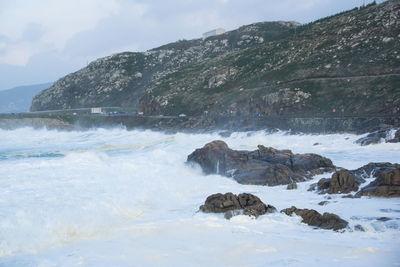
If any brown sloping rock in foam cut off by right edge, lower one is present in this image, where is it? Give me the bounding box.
[356,164,400,197]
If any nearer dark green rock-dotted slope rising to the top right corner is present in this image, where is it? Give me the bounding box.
[140,1,400,116]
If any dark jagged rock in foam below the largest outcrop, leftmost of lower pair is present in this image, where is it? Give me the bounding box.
[200,193,276,219]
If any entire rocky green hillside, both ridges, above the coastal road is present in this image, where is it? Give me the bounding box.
[31,0,400,115]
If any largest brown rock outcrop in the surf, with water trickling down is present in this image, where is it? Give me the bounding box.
[187,141,334,186]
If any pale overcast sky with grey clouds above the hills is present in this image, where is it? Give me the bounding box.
[0,0,383,90]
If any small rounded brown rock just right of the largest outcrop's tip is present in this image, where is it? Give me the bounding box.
[316,170,365,194]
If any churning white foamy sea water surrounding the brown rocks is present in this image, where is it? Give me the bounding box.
[0,128,400,267]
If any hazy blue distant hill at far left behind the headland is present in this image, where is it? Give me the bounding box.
[0,83,53,113]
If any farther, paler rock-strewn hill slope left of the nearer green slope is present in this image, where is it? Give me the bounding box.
[31,22,299,112]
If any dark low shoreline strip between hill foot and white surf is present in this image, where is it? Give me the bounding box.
[0,113,400,134]
